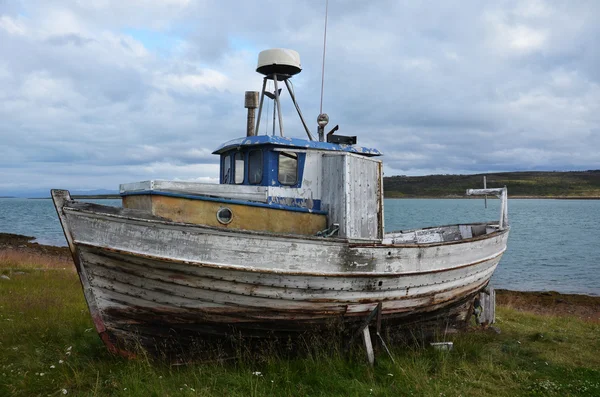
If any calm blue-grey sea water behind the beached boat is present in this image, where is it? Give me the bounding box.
[0,199,600,295]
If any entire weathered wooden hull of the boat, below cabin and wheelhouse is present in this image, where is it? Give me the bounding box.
[53,191,508,355]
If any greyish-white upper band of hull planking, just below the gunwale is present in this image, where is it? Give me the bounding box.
[65,207,508,277]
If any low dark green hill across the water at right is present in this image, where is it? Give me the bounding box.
[383,170,600,198]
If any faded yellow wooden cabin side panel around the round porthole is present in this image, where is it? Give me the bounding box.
[123,195,327,235]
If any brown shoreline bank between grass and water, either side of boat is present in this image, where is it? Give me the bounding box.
[0,233,600,321]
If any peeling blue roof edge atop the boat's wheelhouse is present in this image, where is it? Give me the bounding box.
[213,135,382,156]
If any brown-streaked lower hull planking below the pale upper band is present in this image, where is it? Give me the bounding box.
[81,243,497,331]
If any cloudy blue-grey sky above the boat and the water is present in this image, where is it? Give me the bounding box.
[0,0,600,195]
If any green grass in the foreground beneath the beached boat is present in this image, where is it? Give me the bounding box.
[0,268,600,396]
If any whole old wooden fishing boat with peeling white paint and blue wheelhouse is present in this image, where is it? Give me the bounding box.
[52,50,509,354]
